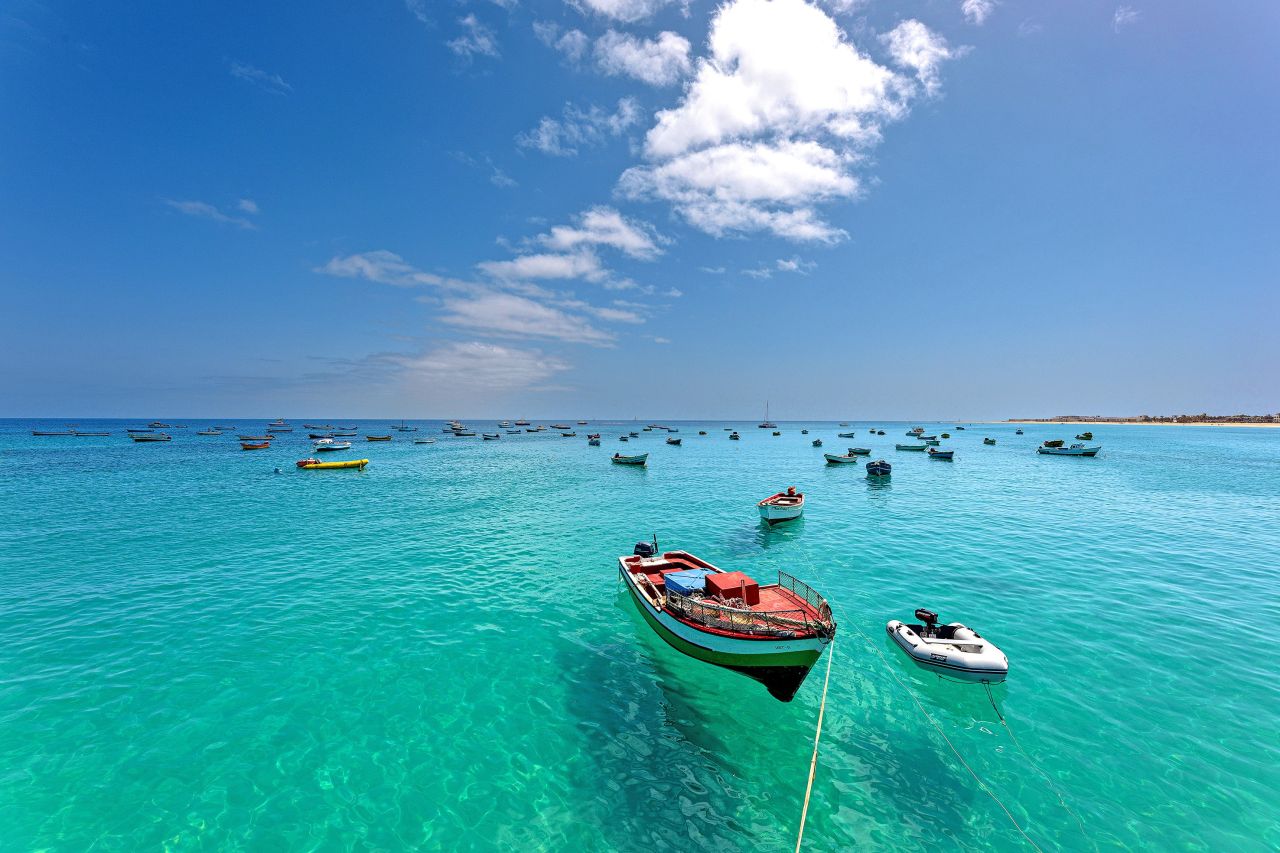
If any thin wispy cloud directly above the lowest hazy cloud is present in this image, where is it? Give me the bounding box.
[440,291,614,346]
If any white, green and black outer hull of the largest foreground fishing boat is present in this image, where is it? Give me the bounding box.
[618,562,829,702]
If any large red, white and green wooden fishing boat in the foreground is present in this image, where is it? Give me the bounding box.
[618,539,836,702]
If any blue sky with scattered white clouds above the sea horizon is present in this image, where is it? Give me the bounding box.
[0,0,1280,419]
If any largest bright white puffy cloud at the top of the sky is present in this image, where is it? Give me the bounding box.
[618,0,955,242]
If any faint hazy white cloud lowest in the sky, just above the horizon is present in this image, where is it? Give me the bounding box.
[394,341,570,392]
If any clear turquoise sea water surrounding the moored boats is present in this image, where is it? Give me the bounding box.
[0,420,1280,850]
